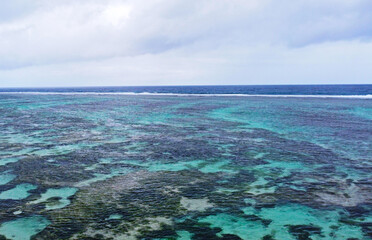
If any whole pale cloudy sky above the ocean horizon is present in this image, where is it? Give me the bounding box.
[0,0,372,87]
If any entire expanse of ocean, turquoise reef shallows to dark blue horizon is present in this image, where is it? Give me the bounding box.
[0,85,372,240]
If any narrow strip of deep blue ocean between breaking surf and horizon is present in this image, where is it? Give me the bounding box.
[0,84,372,95]
